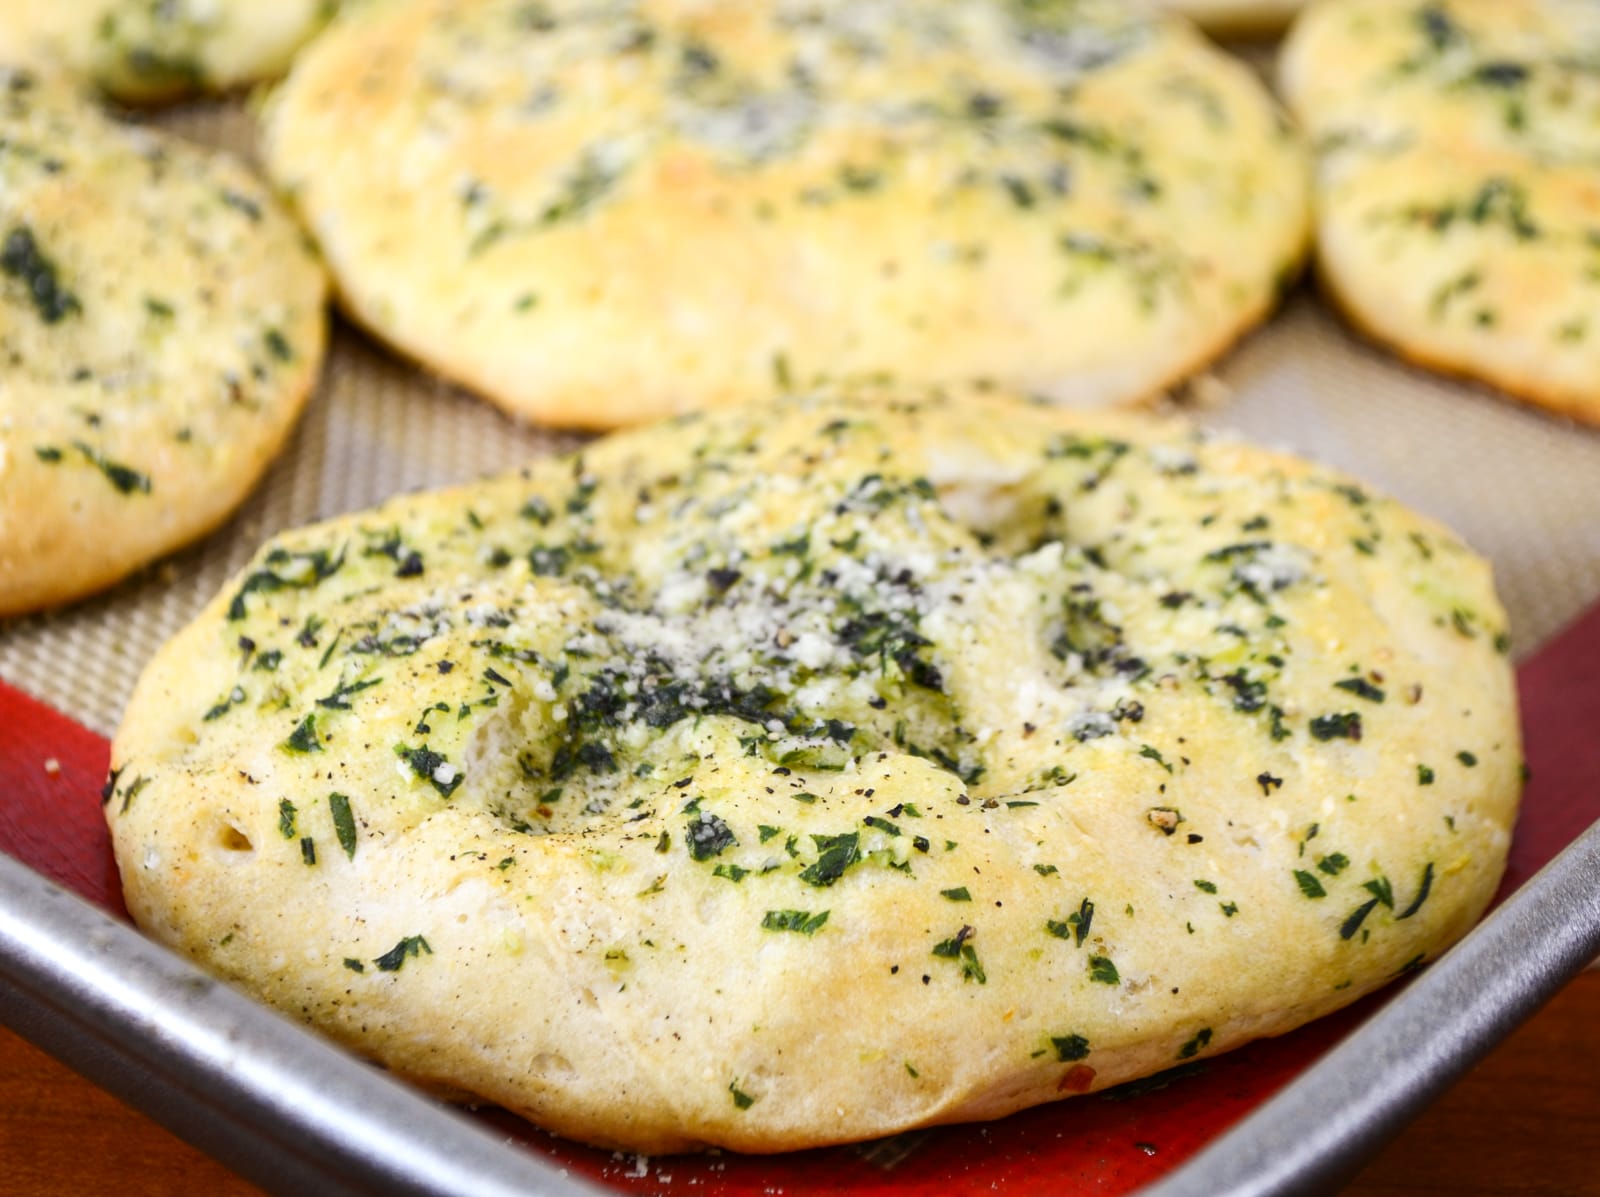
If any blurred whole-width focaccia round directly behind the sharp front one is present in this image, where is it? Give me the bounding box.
[266,0,1309,427]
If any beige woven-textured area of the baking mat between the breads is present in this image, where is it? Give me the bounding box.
[9,106,1600,733]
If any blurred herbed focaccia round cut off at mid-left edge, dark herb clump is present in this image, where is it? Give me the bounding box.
[0,69,326,615]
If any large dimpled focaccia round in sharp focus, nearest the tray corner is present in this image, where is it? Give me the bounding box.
[106,388,1520,1152]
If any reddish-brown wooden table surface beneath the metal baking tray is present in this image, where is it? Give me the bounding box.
[0,970,1600,1197]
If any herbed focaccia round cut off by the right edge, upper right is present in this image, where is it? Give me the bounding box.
[1282,0,1600,424]
